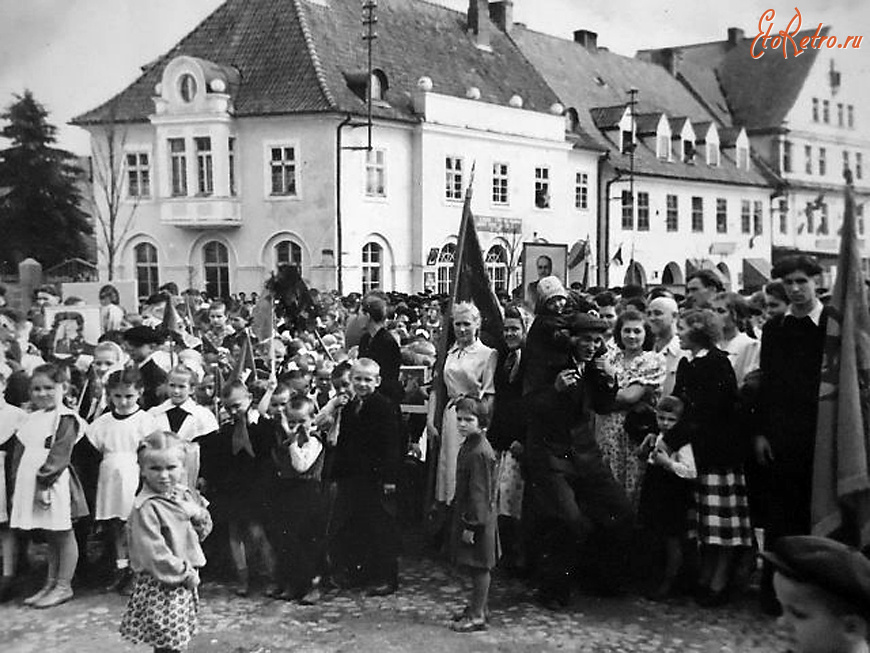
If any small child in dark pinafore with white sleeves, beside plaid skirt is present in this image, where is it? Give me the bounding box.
[638,396,698,600]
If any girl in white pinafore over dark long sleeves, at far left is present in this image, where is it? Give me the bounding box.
[10,365,84,608]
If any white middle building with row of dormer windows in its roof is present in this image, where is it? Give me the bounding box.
[511,26,773,289]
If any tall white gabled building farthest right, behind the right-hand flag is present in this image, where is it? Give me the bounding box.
[638,27,870,284]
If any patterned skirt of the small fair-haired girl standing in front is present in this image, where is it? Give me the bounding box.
[120,572,199,650]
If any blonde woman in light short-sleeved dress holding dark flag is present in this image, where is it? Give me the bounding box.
[427,302,498,505]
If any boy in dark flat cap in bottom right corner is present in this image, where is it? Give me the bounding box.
[762,535,870,653]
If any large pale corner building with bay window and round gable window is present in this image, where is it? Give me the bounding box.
[74,0,600,295]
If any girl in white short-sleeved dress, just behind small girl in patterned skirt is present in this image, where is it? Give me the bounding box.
[87,367,158,592]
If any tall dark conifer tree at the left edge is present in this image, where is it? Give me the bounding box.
[0,91,93,271]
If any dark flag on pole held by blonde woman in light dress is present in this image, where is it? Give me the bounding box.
[427,168,506,510]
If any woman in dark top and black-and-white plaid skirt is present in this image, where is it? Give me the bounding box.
[674,309,752,607]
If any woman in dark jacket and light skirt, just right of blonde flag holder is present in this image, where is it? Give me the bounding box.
[489,306,531,567]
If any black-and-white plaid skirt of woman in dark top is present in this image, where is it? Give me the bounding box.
[689,468,752,547]
